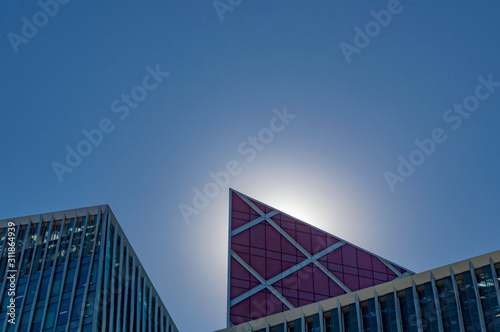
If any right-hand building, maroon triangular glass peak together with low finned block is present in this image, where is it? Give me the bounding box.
[220,191,500,332]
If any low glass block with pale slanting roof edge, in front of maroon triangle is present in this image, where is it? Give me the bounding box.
[219,251,500,332]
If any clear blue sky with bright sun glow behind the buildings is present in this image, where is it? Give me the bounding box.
[0,0,500,331]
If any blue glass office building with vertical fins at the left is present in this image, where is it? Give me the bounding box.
[0,205,178,332]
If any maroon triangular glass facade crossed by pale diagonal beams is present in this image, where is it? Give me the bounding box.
[228,190,413,326]
